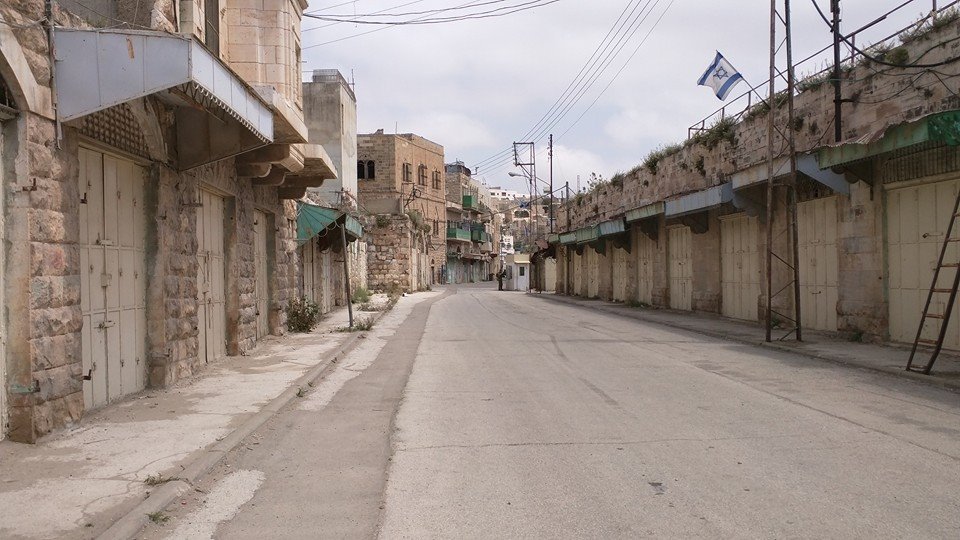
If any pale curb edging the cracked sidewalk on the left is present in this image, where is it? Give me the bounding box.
[97,306,393,540]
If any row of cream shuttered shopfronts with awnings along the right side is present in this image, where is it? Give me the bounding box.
[551,112,960,349]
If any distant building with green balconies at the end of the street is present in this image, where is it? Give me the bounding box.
[444,162,499,283]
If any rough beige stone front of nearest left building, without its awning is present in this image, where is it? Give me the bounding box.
[0,0,320,441]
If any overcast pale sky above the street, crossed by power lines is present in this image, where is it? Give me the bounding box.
[302,0,945,191]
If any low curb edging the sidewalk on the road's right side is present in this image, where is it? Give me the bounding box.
[539,294,960,392]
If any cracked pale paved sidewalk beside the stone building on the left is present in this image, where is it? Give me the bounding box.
[0,295,386,539]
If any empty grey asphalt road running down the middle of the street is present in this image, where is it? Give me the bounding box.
[146,286,960,538]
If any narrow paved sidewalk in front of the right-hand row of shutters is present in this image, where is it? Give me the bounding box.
[530,293,960,390]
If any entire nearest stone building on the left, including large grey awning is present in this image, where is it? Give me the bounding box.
[0,0,335,441]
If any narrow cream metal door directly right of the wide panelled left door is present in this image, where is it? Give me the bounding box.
[197,189,227,362]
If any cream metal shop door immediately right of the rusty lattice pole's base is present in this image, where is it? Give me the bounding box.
[797,196,840,332]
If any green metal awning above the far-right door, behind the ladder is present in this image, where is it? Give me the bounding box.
[817,110,960,169]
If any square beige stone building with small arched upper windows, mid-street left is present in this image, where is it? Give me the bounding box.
[357,129,447,290]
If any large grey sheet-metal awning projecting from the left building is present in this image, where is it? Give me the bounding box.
[54,28,274,170]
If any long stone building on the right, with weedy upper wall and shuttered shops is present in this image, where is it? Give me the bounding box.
[552,12,960,349]
